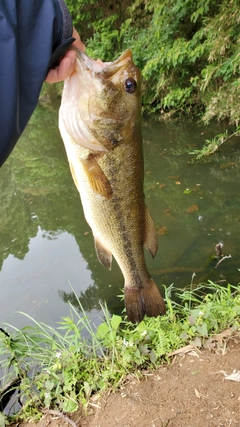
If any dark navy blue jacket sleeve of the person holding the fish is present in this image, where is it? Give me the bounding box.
[0,0,74,166]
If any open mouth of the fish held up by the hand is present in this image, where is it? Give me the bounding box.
[77,49,132,77]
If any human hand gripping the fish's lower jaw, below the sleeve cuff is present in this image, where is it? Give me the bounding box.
[46,28,85,83]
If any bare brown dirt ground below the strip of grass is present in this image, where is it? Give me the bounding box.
[10,333,240,427]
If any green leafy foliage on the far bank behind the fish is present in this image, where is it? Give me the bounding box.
[67,0,240,126]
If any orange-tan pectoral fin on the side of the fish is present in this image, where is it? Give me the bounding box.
[81,155,112,199]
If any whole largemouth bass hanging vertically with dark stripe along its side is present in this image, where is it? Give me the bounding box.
[59,49,166,323]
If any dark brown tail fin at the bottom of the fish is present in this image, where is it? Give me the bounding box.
[124,278,166,323]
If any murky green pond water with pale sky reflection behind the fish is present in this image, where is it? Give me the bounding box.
[0,92,240,327]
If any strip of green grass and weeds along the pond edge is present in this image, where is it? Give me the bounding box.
[0,282,240,425]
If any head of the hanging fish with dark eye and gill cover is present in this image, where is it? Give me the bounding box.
[61,49,141,151]
